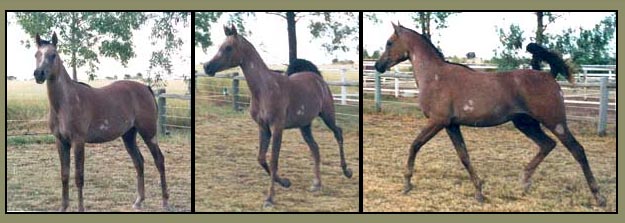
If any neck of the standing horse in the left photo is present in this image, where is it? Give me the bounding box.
[46,66,74,111]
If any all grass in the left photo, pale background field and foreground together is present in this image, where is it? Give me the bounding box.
[6,81,191,212]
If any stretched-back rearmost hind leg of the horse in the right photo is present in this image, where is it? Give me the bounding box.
[549,122,606,207]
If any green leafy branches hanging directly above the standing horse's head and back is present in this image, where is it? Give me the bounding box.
[15,12,146,80]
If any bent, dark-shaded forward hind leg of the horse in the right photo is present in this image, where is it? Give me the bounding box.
[512,116,556,193]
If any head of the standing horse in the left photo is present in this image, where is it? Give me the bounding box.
[34,32,62,84]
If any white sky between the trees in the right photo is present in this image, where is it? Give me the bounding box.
[363,12,616,59]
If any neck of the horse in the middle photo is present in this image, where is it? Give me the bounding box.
[241,47,279,100]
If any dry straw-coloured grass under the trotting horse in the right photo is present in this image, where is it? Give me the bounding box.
[363,114,616,212]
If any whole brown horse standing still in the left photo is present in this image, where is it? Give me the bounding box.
[34,33,169,211]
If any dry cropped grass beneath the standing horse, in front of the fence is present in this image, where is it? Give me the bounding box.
[6,139,191,212]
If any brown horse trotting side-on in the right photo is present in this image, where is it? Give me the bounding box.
[375,24,606,206]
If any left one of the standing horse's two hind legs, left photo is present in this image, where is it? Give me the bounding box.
[122,128,145,209]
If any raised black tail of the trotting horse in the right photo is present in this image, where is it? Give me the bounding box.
[525,43,575,83]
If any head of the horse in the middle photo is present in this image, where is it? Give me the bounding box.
[204,25,244,76]
